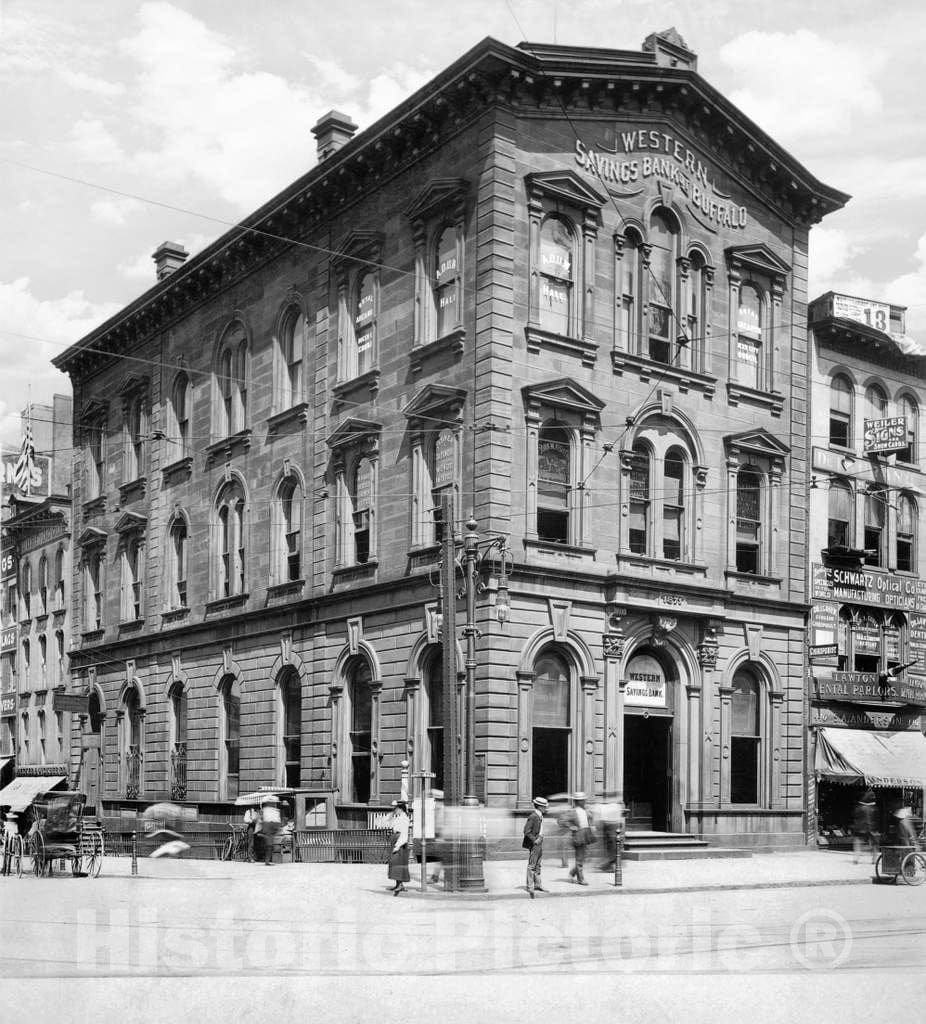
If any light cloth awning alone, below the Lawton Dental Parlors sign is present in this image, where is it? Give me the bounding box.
[813,728,926,787]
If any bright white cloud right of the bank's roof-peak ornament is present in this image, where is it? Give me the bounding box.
[719,29,885,143]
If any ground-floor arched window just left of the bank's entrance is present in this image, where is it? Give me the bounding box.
[532,649,573,796]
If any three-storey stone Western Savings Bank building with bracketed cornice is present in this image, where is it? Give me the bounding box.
[55,31,848,846]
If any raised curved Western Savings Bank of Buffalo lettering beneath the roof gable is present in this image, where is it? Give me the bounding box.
[576,128,747,228]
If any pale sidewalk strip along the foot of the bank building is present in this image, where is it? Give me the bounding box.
[100,850,875,901]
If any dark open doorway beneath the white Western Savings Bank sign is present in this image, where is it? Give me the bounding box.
[624,714,672,831]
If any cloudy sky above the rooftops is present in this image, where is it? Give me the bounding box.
[0,0,926,451]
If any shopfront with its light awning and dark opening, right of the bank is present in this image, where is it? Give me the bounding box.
[813,727,926,846]
